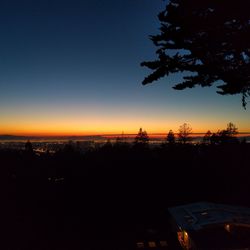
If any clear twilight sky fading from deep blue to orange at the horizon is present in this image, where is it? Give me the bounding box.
[0,0,250,135]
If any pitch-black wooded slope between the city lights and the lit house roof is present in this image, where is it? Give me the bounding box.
[0,140,250,249]
